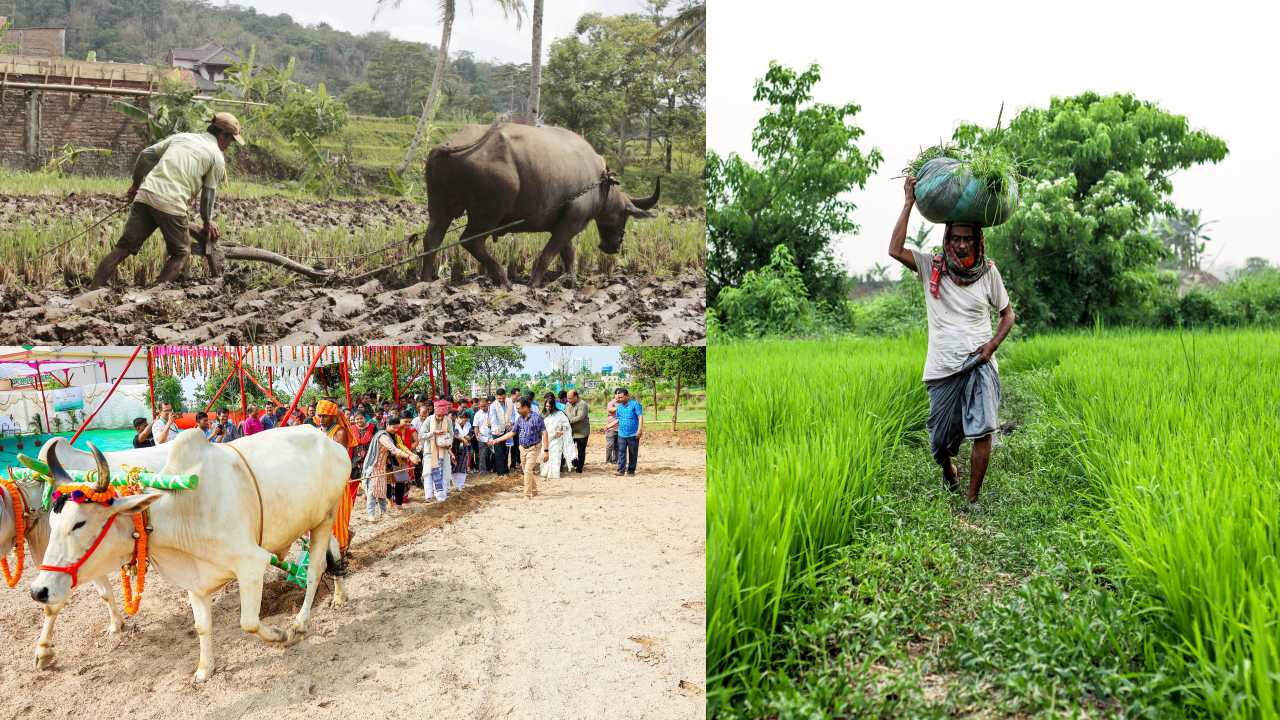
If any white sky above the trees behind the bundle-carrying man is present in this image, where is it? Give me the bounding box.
[707,0,1280,272]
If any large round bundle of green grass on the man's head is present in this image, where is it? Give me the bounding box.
[906,145,1018,227]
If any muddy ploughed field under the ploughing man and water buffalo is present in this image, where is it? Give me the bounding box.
[0,195,707,345]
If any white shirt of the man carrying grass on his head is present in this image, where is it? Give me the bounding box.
[911,250,1009,381]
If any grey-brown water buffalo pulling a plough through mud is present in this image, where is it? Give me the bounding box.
[420,123,662,288]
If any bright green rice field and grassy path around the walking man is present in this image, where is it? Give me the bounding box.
[707,331,1280,717]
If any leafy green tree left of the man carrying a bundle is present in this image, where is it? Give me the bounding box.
[707,63,883,305]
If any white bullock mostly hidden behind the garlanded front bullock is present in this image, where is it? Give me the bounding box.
[0,437,168,669]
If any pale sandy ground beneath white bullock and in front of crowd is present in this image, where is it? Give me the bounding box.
[0,432,705,720]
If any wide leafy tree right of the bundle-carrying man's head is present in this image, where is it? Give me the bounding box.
[955,92,1228,327]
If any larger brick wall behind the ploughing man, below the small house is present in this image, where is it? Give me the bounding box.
[0,90,151,174]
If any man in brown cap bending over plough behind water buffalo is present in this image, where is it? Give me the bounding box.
[90,113,244,290]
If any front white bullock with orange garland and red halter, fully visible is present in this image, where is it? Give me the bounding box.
[31,425,351,683]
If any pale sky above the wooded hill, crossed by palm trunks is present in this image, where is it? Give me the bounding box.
[236,0,650,63]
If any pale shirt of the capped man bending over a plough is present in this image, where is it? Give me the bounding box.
[134,132,227,218]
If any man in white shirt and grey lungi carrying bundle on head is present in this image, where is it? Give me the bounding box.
[888,177,1014,503]
